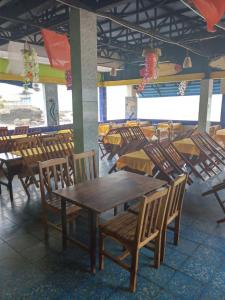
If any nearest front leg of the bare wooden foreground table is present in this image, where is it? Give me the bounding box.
[90,211,97,274]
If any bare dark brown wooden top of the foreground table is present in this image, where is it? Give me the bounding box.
[54,171,167,213]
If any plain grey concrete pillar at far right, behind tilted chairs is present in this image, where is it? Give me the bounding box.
[198,79,213,132]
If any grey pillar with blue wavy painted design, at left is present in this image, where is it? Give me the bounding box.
[44,83,59,126]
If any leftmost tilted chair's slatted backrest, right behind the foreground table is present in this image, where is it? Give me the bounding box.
[143,143,176,180]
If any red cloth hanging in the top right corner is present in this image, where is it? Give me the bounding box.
[192,0,225,32]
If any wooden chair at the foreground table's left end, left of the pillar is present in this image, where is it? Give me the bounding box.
[39,158,81,239]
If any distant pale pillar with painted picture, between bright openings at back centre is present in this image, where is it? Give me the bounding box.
[125,85,137,119]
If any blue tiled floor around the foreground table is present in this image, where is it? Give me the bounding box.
[0,162,225,300]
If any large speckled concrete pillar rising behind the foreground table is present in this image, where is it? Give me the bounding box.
[70,9,98,153]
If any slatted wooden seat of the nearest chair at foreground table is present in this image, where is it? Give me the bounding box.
[100,212,138,243]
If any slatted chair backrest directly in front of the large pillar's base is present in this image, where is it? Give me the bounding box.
[73,150,98,184]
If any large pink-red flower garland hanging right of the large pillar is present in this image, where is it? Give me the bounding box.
[137,48,161,93]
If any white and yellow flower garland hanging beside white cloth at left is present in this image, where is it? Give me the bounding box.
[22,42,39,91]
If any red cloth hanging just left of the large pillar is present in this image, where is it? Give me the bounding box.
[41,29,71,71]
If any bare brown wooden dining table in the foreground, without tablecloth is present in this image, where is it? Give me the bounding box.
[54,171,167,273]
